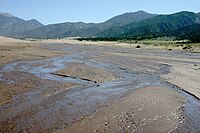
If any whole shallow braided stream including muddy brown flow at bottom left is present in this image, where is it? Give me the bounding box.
[0,44,200,132]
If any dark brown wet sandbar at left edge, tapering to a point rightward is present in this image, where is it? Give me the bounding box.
[0,71,78,106]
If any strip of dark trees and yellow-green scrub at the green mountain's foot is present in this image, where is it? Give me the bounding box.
[77,37,200,52]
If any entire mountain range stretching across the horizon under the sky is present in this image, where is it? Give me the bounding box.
[0,11,200,42]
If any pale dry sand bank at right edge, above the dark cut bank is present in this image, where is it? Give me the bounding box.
[161,63,200,99]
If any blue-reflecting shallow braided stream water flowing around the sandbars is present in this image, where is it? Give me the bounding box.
[0,44,200,132]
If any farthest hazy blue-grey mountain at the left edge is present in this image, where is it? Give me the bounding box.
[0,13,43,36]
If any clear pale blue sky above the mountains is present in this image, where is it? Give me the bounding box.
[0,0,200,24]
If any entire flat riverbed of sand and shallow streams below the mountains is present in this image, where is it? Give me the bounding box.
[0,38,200,132]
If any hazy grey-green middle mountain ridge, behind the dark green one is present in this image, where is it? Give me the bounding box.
[18,11,156,38]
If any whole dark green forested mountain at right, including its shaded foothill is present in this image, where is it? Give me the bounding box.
[80,12,200,43]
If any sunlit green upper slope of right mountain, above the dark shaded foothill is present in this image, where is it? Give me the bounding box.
[97,11,200,37]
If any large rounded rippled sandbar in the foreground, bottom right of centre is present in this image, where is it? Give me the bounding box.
[56,86,185,133]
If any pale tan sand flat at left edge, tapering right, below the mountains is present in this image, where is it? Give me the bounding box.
[0,36,67,66]
